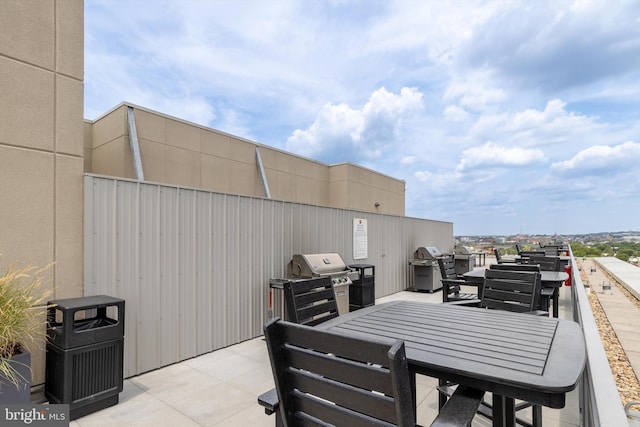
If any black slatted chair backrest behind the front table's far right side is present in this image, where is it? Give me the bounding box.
[480,268,541,313]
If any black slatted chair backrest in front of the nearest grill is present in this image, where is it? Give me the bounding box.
[284,277,339,326]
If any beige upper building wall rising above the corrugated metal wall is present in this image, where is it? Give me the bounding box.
[85,104,405,216]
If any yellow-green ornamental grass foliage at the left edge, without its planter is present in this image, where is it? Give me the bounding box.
[0,264,51,386]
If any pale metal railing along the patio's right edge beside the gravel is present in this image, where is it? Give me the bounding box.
[570,252,628,427]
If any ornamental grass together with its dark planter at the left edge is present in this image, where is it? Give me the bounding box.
[0,264,50,404]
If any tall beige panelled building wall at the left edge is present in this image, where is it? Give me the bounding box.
[0,0,84,384]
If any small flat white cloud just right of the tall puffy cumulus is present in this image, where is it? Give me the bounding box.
[456,142,544,172]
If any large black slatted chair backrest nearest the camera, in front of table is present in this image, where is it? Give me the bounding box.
[264,319,415,426]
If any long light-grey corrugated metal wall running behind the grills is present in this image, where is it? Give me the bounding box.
[85,175,453,376]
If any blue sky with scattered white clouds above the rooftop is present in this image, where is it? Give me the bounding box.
[84,0,640,236]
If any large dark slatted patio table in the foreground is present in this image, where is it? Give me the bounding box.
[316,301,585,426]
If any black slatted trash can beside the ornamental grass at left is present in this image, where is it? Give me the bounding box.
[45,295,124,420]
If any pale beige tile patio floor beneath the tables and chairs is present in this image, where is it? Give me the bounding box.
[71,287,579,427]
